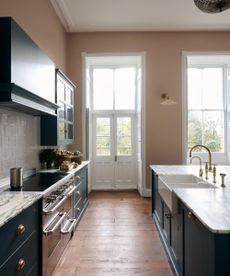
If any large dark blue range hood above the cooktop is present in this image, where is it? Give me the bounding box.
[0,17,57,115]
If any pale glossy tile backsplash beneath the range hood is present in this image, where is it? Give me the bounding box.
[0,107,40,179]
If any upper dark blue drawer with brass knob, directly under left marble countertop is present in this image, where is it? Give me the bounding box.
[0,202,39,266]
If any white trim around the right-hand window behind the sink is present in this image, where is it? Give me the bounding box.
[182,51,230,164]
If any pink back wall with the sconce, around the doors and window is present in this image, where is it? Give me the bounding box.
[67,32,230,186]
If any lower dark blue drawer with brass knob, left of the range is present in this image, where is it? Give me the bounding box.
[0,232,38,276]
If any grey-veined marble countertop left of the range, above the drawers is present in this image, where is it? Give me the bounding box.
[0,192,42,227]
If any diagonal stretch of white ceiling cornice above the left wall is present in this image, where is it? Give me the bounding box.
[50,0,73,32]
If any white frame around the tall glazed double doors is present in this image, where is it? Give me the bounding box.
[81,52,146,197]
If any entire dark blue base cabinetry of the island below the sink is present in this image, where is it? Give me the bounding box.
[152,172,230,276]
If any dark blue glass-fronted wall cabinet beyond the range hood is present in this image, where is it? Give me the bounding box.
[41,70,75,146]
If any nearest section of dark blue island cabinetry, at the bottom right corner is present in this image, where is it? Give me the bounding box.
[179,202,230,276]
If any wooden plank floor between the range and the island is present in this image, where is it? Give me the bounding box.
[53,192,173,276]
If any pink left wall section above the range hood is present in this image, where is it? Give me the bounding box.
[0,0,66,71]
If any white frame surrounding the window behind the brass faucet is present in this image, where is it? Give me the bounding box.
[182,52,230,164]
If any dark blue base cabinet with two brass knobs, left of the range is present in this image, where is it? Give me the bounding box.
[0,201,42,276]
